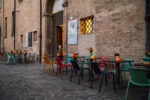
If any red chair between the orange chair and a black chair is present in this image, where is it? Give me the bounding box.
[55,58,72,79]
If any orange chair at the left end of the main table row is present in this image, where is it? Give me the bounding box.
[42,56,56,74]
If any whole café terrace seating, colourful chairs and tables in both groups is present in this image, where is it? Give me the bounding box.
[1,48,150,100]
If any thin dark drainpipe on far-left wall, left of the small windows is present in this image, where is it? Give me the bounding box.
[13,0,16,50]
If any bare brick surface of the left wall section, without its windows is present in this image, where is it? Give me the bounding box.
[1,0,40,54]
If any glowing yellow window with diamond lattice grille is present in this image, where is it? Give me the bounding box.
[80,16,94,34]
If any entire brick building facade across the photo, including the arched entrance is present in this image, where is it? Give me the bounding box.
[1,0,149,60]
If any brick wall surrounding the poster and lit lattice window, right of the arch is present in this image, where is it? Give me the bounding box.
[64,0,145,61]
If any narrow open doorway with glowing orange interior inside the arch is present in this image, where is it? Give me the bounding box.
[57,25,64,54]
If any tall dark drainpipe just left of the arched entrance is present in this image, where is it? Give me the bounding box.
[39,0,42,63]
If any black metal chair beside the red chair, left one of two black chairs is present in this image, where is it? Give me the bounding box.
[70,60,89,84]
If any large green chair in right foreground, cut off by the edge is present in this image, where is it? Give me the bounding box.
[125,67,150,100]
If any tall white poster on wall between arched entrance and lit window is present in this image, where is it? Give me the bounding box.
[68,20,77,44]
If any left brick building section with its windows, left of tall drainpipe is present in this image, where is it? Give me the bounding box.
[1,0,40,54]
